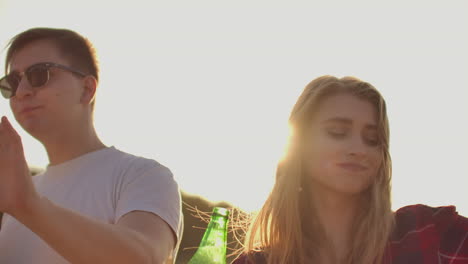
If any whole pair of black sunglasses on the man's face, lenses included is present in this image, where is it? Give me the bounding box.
[0,62,86,99]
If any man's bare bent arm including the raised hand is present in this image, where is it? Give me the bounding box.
[0,117,175,264]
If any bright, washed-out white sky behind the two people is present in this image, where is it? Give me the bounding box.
[0,0,468,215]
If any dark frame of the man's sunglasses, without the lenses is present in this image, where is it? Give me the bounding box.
[0,62,87,99]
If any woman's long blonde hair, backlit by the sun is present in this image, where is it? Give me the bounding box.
[244,76,394,264]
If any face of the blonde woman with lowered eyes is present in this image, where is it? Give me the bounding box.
[304,94,382,195]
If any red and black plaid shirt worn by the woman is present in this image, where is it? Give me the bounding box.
[233,204,468,264]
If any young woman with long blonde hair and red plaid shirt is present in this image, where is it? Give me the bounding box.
[233,76,468,264]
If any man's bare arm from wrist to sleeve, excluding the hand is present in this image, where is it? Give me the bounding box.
[13,198,175,264]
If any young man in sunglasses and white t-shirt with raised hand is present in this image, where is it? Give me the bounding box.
[0,28,182,264]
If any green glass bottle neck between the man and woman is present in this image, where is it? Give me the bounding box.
[188,207,229,264]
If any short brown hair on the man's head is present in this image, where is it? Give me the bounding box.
[5,28,99,81]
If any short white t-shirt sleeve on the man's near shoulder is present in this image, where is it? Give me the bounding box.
[115,162,182,242]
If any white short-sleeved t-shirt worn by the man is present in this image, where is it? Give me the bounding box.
[0,147,183,264]
